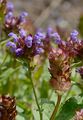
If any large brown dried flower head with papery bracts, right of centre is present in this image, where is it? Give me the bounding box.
[49,49,71,91]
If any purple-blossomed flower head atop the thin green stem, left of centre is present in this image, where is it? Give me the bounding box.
[6,29,44,58]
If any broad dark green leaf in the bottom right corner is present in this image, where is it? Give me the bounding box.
[56,97,83,120]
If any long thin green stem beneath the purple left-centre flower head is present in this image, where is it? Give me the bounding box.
[28,64,42,120]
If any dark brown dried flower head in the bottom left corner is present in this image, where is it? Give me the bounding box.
[0,96,17,120]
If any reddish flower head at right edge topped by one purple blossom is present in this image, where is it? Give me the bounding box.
[56,30,83,58]
